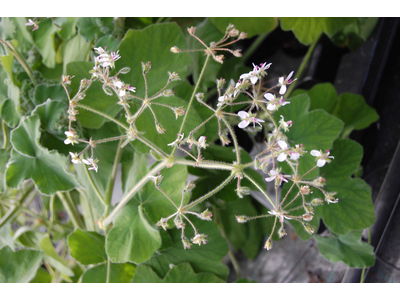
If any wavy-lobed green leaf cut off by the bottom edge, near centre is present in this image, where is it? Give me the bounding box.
[132,263,225,283]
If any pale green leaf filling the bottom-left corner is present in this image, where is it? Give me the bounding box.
[0,246,43,283]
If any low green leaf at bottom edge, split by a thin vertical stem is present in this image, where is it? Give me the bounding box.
[82,263,136,283]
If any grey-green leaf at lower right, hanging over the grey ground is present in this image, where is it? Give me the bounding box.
[315,231,375,268]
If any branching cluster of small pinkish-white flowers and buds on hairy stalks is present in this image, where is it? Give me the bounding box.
[63,25,338,250]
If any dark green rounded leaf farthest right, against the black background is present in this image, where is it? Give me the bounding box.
[335,93,379,137]
